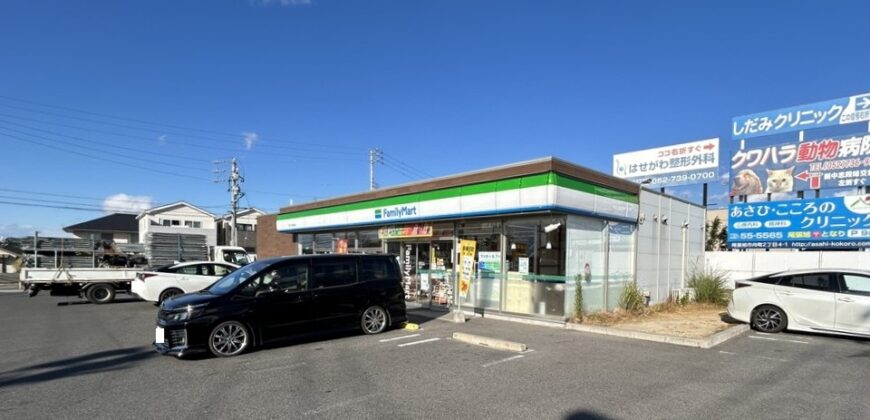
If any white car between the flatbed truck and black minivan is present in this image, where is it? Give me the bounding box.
[130,261,239,303]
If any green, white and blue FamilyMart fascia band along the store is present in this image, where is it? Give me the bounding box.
[277,172,638,232]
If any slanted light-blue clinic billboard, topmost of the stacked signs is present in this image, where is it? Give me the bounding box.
[731,93,870,140]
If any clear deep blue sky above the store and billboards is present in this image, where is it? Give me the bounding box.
[0,0,870,236]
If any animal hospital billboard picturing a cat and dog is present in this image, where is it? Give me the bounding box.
[731,134,870,196]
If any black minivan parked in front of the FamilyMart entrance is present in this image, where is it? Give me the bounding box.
[154,255,407,357]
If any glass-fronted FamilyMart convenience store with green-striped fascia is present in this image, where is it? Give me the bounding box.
[277,158,652,319]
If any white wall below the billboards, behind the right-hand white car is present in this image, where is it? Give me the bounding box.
[704,251,870,288]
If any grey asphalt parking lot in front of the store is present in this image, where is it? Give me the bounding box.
[0,291,870,419]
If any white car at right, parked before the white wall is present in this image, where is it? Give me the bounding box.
[728,269,870,337]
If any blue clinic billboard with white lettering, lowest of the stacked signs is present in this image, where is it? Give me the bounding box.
[728,195,870,248]
